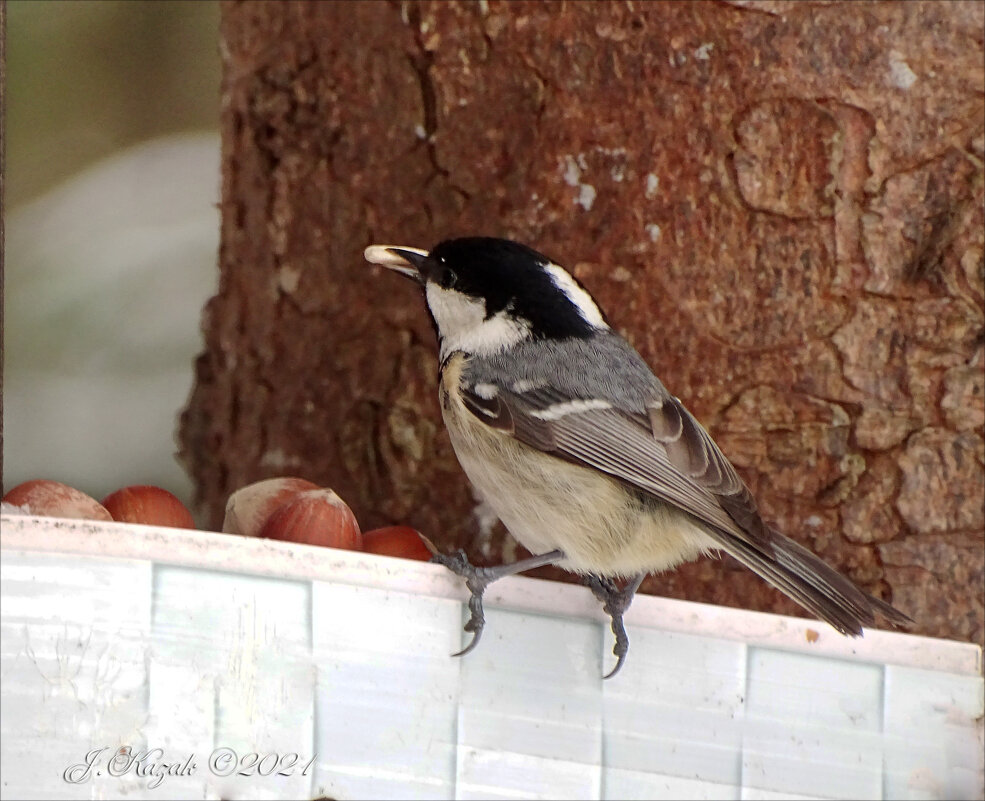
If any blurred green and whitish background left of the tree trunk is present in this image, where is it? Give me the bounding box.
[3,0,220,503]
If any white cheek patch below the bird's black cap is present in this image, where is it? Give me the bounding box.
[426,282,530,359]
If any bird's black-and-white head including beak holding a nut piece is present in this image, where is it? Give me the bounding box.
[365,237,608,350]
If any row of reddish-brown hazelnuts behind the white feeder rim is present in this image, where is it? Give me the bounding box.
[3,477,431,562]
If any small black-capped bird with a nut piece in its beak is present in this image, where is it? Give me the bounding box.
[365,237,912,678]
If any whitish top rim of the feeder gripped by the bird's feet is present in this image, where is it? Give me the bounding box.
[0,514,982,676]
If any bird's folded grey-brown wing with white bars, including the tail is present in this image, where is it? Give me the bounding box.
[460,345,909,635]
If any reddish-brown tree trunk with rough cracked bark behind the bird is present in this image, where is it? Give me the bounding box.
[180,0,985,643]
